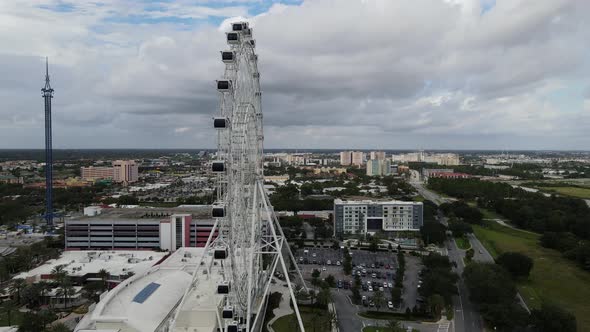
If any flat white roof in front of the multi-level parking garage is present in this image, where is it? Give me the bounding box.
[16,250,166,278]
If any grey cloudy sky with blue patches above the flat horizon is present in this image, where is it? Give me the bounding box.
[0,0,590,149]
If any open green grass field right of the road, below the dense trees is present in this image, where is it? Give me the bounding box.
[473,221,590,331]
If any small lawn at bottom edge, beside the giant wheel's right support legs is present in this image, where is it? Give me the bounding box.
[272,306,330,332]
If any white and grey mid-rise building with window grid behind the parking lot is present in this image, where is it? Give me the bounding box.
[334,199,423,236]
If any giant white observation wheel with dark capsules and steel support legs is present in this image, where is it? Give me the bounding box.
[169,22,305,332]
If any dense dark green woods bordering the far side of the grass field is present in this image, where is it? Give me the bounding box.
[429,179,590,270]
